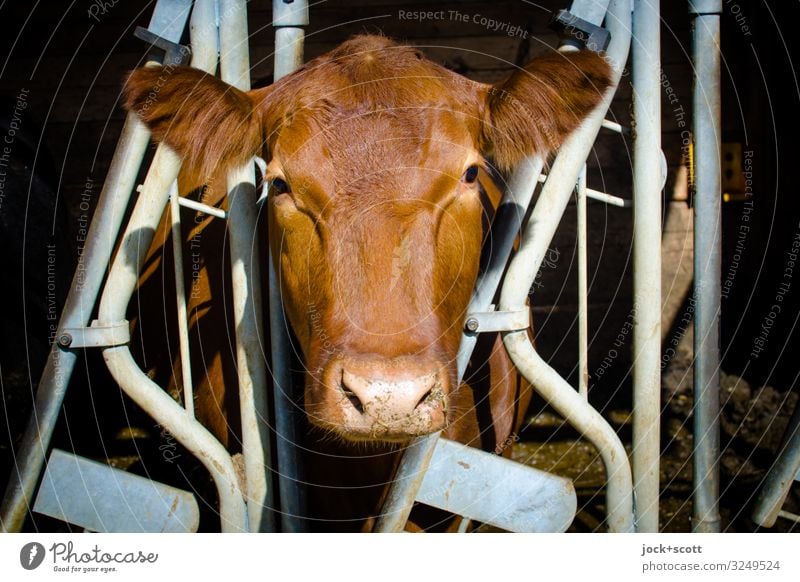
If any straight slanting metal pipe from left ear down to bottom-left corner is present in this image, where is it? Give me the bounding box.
[0,113,150,532]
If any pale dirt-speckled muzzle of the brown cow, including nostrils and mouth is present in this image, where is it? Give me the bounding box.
[320,357,449,441]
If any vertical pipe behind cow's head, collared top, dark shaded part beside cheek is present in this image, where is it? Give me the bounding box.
[269,0,308,532]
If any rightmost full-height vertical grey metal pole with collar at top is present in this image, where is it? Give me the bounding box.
[689,0,722,532]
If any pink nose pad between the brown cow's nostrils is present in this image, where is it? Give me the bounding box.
[342,370,437,420]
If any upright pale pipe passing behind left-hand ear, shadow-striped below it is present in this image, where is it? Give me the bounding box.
[219,0,275,532]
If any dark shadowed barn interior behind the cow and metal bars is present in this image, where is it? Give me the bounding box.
[0,0,800,531]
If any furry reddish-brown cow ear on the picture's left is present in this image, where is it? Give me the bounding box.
[123,67,262,180]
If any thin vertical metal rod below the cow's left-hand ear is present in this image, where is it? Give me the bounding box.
[169,180,194,416]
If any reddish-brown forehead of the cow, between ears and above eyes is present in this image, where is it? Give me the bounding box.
[268,37,482,188]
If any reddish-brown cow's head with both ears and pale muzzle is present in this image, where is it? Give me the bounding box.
[126,36,610,441]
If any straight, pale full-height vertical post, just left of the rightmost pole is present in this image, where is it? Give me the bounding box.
[632,0,663,532]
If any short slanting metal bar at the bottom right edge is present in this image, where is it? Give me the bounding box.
[753,404,800,527]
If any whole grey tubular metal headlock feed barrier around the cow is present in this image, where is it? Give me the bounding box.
[0,0,736,532]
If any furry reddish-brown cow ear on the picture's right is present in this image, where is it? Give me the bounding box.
[481,51,611,171]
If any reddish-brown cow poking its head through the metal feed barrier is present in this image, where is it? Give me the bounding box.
[124,35,611,530]
